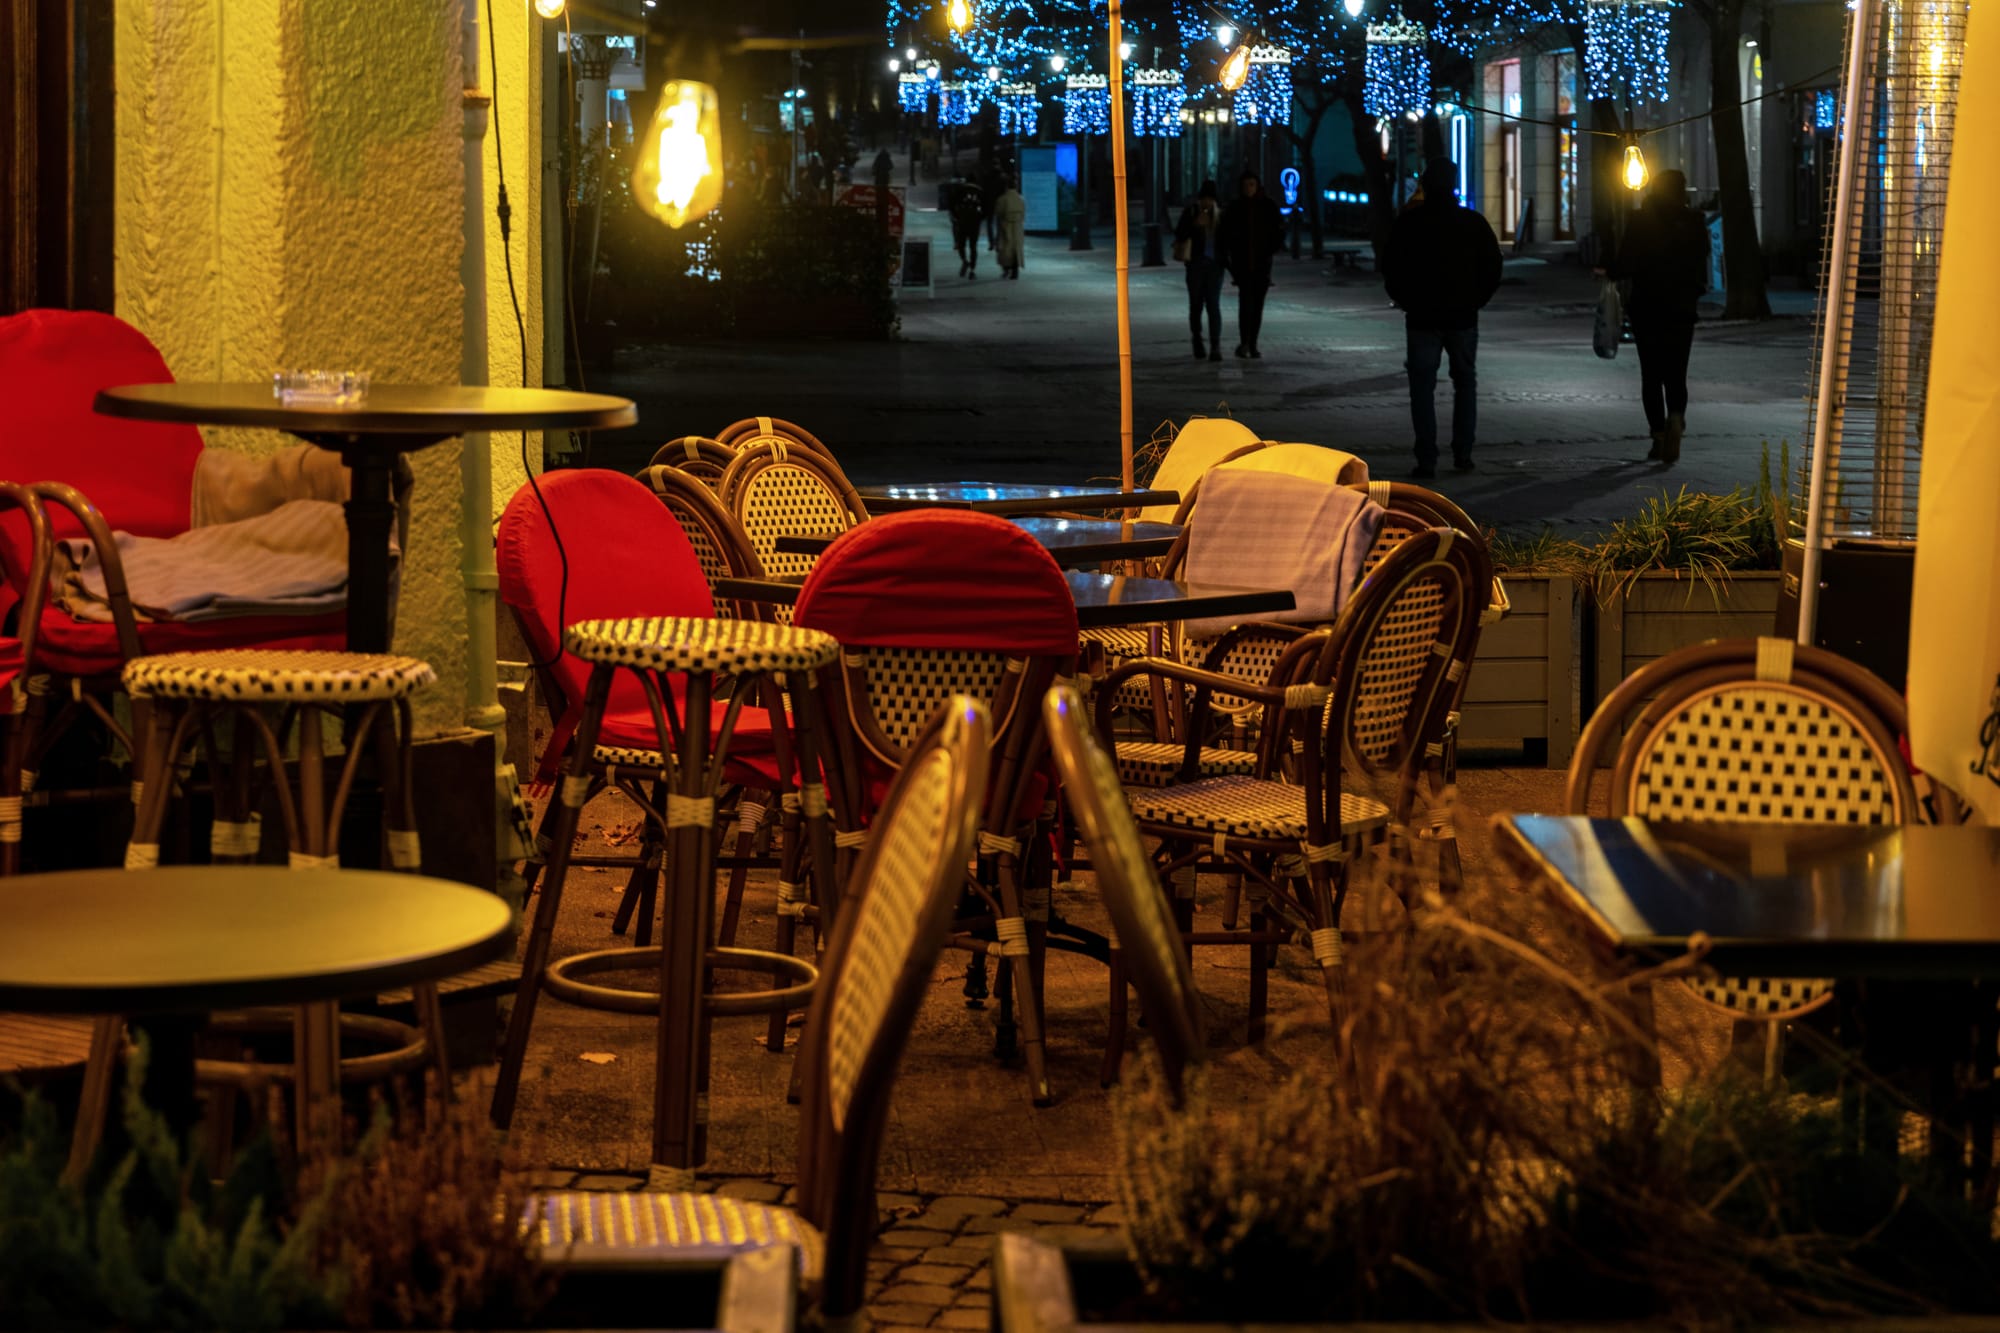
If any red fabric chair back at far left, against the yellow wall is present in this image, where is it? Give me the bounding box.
[0,310,202,586]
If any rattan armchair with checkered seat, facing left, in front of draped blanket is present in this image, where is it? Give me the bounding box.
[1098,528,1490,1016]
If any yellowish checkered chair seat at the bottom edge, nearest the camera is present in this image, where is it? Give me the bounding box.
[524,1189,826,1283]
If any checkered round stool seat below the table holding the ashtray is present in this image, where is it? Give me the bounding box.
[124,648,438,705]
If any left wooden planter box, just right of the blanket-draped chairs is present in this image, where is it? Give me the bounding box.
[1458,572,1584,769]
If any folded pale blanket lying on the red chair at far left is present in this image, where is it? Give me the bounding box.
[58,500,396,620]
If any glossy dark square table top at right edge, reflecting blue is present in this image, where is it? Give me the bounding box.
[1494,815,2000,981]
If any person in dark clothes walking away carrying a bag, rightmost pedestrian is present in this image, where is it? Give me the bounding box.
[1610,170,1708,466]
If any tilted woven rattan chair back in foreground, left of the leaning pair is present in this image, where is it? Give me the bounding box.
[798,699,990,1319]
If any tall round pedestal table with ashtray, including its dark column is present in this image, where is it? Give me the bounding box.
[94,380,638,652]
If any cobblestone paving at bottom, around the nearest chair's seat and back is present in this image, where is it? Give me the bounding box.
[516,1171,1124,1333]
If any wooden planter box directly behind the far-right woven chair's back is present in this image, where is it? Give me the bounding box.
[1590,570,1784,711]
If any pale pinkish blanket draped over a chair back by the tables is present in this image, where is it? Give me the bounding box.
[1182,466,1384,636]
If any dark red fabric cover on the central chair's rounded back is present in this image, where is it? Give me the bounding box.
[792,508,1076,656]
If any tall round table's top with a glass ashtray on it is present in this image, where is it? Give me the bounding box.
[94,380,638,440]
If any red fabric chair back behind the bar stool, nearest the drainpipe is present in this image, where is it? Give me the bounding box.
[496,468,716,711]
